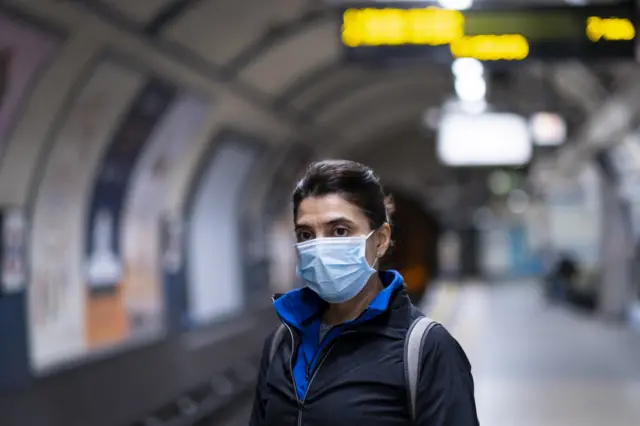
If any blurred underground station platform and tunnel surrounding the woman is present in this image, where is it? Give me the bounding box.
[0,0,640,426]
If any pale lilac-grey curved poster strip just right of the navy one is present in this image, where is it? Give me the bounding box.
[122,93,209,334]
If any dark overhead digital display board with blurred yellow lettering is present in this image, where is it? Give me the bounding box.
[340,2,637,62]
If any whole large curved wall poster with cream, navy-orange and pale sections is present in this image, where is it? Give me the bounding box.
[28,59,210,373]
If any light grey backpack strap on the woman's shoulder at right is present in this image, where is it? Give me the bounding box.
[404,316,438,421]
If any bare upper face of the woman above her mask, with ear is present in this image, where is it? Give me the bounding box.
[295,194,391,265]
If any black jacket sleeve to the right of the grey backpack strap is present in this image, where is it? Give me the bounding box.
[416,326,480,426]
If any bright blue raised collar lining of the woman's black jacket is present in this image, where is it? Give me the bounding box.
[273,270,404,329]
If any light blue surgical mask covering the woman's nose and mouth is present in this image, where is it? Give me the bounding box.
[296,231,376,303]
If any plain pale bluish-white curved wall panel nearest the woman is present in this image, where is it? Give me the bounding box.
[185,141,259,326]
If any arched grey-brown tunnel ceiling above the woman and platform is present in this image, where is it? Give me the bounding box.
[13,0,637,220]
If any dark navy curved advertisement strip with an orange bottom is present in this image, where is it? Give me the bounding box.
[84,79,177,348]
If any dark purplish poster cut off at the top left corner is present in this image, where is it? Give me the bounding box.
[0,12,60,157]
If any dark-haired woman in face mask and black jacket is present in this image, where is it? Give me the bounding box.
[251,161,479,426]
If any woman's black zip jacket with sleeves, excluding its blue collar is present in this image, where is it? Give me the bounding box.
[250,288,479,426]
